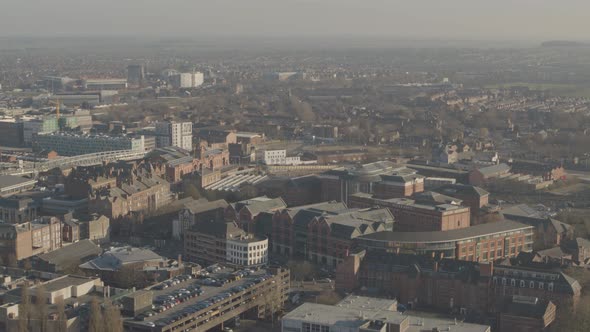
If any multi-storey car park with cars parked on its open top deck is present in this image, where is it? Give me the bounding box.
[124,268,290,332]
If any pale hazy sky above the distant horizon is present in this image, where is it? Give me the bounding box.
[0,0,590,40]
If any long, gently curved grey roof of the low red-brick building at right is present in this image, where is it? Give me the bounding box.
[359,220,533,243]
